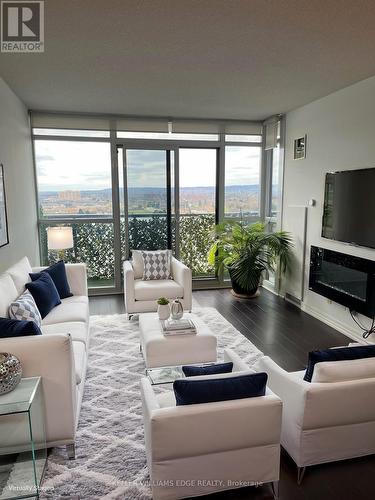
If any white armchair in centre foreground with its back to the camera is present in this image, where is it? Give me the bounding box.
[141,349,282,500]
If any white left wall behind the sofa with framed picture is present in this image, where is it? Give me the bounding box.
[0,78,39,273]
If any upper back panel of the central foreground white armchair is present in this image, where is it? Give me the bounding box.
[150,395,282,461]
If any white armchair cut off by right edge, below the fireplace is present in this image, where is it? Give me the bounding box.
[256,356,375,483]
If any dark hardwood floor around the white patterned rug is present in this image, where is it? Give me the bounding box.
[90,289,375,500]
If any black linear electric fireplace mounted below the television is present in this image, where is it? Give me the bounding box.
[309,246,375,318]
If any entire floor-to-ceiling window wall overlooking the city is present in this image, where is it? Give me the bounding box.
[33,115,279,293]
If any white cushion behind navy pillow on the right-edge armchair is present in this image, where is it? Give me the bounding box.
[311,358,375,383]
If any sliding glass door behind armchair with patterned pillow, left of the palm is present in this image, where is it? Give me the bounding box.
[119,145,218,278]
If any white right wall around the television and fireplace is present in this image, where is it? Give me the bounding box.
[283,77,375,342]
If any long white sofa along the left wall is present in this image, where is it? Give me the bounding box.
[0,257,89,458]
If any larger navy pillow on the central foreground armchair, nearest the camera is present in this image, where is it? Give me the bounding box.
[173,373,267,406]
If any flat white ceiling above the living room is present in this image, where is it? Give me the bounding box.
[0,0,375,120]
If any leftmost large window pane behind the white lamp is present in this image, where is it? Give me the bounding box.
[34,140,115,288]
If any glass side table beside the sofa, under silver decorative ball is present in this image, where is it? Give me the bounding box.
[0,377,47,500]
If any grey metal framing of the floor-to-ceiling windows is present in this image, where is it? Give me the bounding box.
[31,124,283,295]
